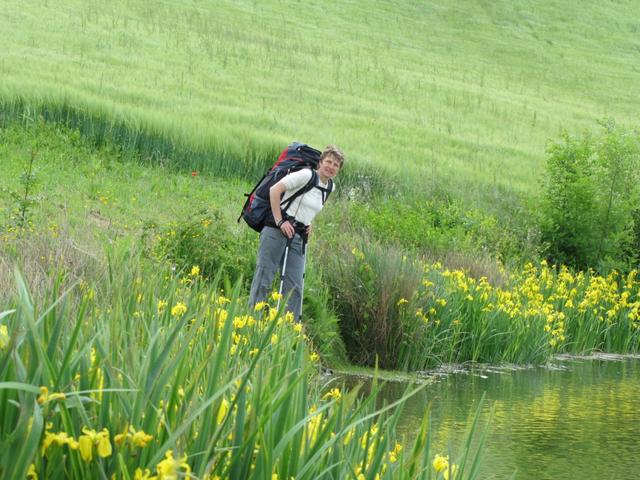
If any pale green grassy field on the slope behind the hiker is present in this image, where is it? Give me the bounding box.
[0,0,640,200]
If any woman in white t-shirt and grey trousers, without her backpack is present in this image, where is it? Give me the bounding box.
[249,145,344,322]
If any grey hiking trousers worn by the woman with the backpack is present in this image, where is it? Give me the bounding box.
[249,227,304,321]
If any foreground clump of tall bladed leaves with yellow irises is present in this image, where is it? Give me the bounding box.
[0,253,488,479]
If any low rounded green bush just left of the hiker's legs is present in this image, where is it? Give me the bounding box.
[145,210,258,281]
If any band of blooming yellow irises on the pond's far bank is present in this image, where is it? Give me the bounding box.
[416,262,640,348]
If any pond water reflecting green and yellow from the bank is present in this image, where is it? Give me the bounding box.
[336,356,640,480]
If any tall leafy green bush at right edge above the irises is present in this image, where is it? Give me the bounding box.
[541,122,640,270]
